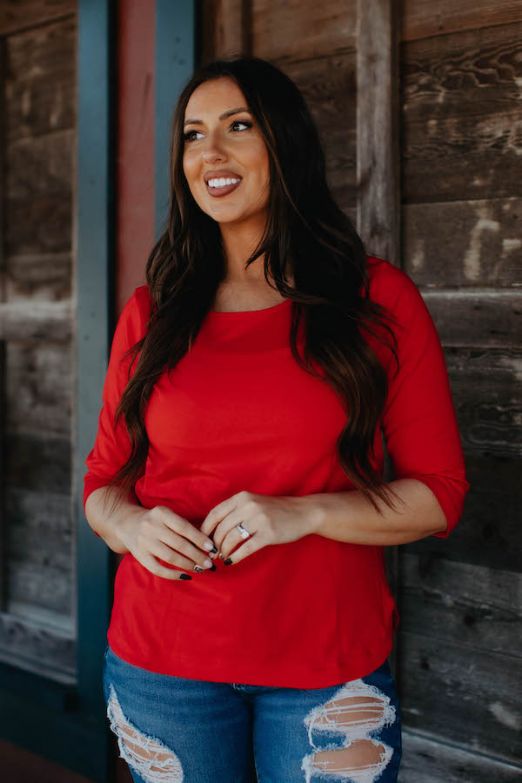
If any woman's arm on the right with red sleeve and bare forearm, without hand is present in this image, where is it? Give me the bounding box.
[303,264,470,545]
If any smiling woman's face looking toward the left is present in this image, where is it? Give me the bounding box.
[183,77,269,225]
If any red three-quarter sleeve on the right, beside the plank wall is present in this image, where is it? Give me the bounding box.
[374,267,470,538]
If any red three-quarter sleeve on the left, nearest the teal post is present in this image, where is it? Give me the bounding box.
[83,286,148,508]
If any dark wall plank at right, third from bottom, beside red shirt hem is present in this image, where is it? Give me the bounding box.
[400,547,522,658]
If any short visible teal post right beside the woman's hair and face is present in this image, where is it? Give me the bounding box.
[154,0,196,237]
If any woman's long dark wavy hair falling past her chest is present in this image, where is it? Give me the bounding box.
[103,57,397,511]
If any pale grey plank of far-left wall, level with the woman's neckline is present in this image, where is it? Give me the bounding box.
[0,302,73,343]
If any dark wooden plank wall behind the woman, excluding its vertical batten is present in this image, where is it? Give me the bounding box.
[201,0,522,783]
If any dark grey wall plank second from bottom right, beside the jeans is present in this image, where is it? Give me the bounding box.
[398,631,522,764]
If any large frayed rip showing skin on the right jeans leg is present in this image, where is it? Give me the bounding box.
[301,679,396,783]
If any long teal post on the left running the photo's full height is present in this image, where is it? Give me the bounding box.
[74,0,117,781]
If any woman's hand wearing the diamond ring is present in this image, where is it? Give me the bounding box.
[200,490,314,565]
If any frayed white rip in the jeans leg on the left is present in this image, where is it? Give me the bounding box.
[107,685,184,783]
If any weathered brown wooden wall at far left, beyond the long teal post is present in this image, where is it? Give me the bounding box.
[0,0,76,682]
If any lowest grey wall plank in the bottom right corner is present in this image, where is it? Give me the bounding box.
[399,729,522,783]
